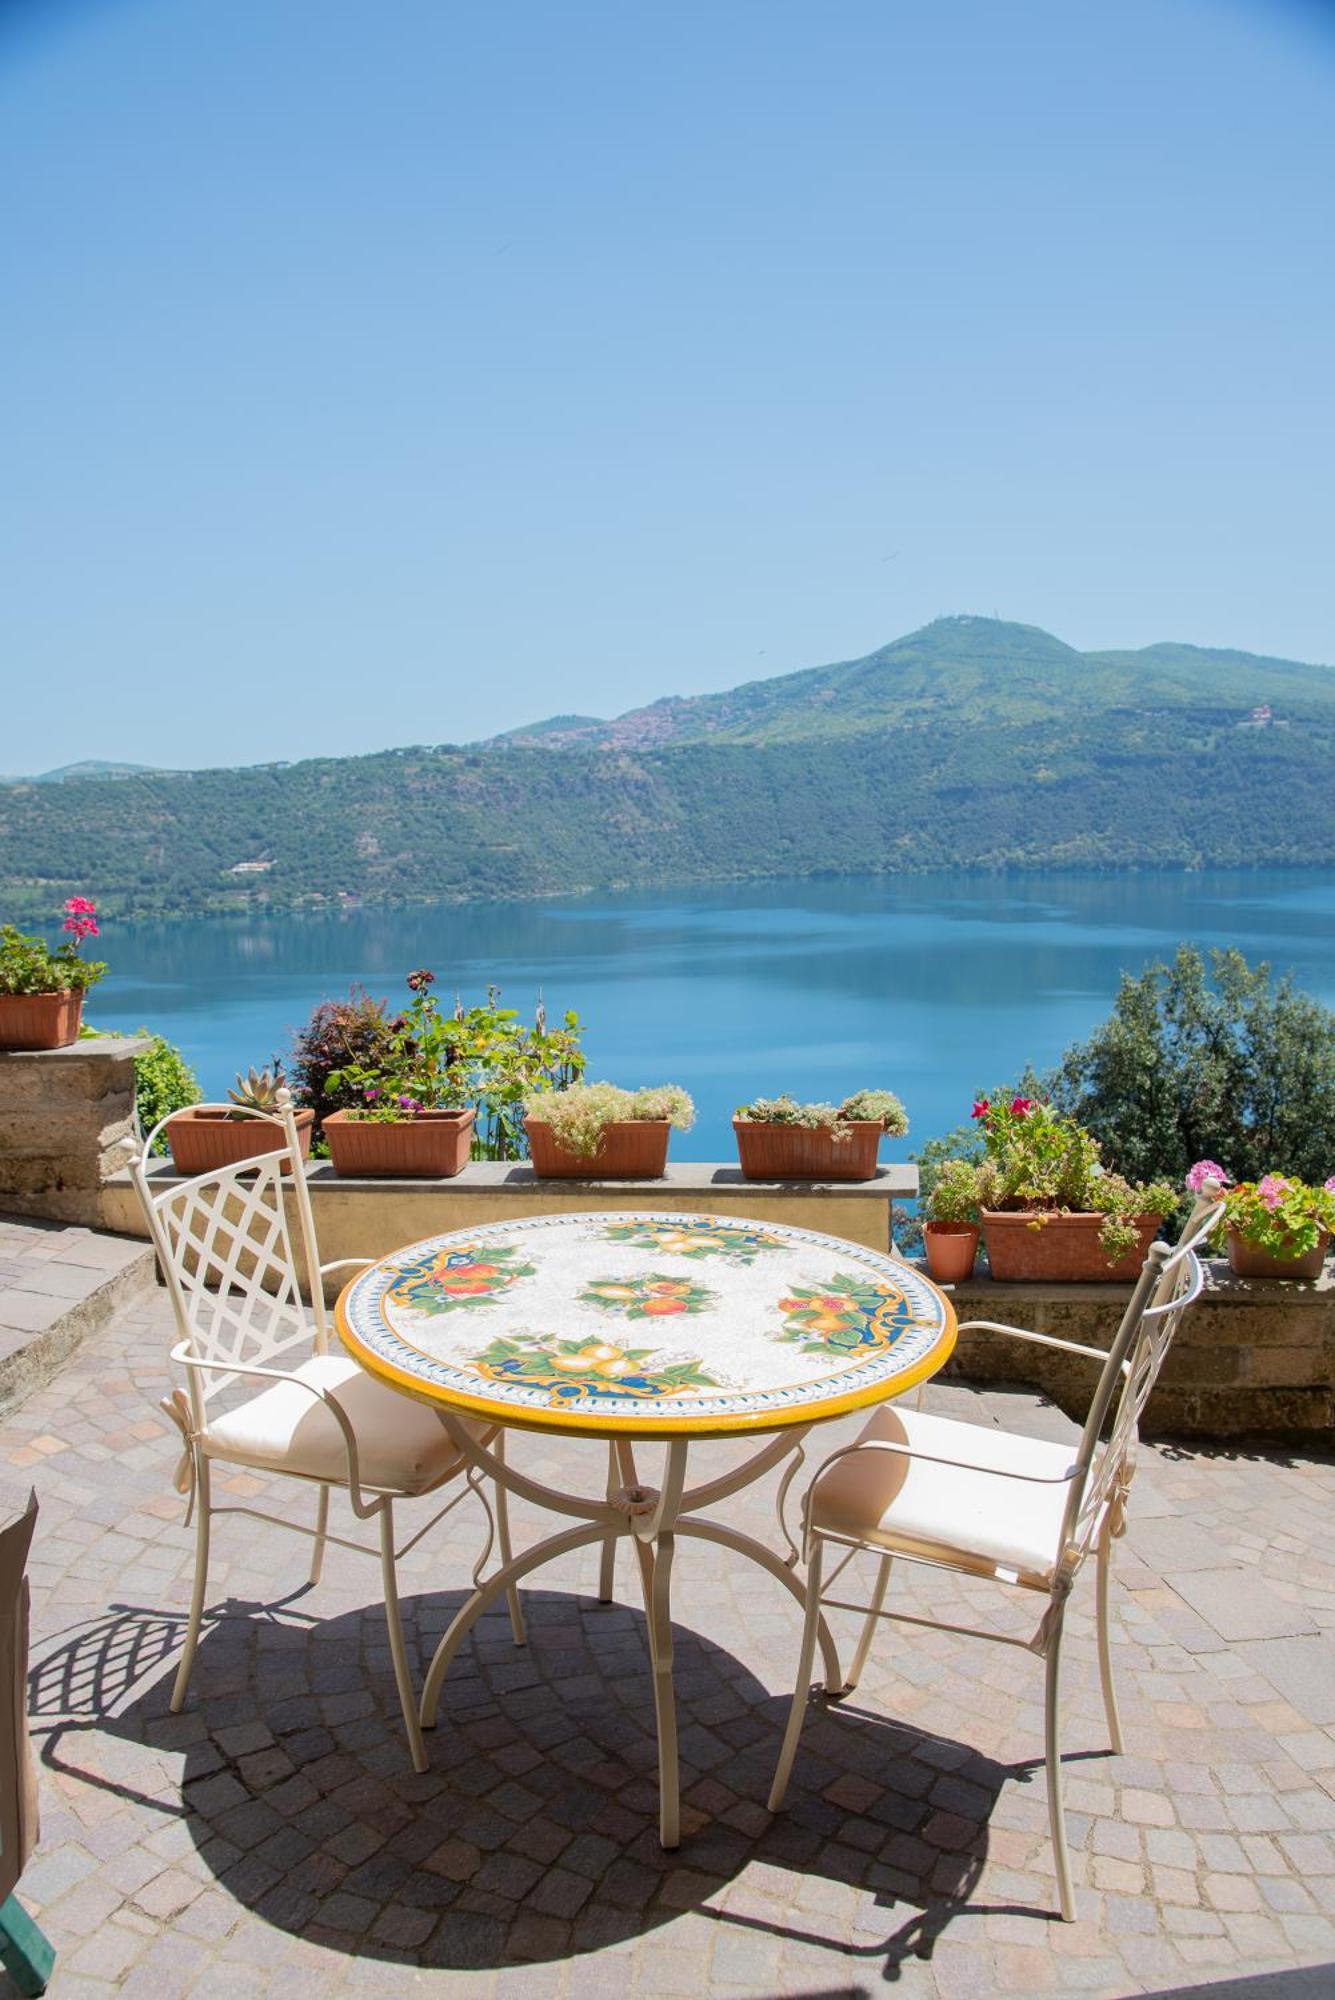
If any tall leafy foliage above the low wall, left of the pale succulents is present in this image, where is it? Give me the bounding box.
[319,968,584,1160]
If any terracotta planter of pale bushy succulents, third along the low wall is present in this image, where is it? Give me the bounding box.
[524,1084,695,1180]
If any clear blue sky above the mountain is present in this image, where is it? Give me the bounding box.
[0,0,1335,770]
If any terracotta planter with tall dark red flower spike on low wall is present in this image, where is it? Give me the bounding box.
[324,968,474,1180]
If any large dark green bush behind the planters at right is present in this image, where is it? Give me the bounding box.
[1051,946,1335,1184]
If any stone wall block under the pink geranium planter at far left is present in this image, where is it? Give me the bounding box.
[0,1036,150,1228]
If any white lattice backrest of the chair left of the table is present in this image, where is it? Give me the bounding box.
[130,1090,330,1422]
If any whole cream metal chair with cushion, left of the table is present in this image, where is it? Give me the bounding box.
[130,1090,524,1770]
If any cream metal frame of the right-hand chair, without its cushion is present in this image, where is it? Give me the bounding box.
[769,1182,1221,1920]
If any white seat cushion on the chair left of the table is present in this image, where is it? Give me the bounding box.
[204,1354,473,1492]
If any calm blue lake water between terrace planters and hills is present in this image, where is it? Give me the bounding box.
[88,870,1335,1160]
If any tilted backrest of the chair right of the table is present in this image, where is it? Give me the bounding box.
[1061,1182,1223,1562]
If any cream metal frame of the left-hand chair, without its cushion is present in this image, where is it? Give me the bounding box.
[130,1092,526,1772]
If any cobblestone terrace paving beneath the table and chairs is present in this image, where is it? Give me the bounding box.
[0,1298,1335,2000]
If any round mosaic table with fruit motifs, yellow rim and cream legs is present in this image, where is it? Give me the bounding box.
[338,1210,955,1848]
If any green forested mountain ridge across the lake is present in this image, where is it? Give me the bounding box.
[0,618,1335,922]
